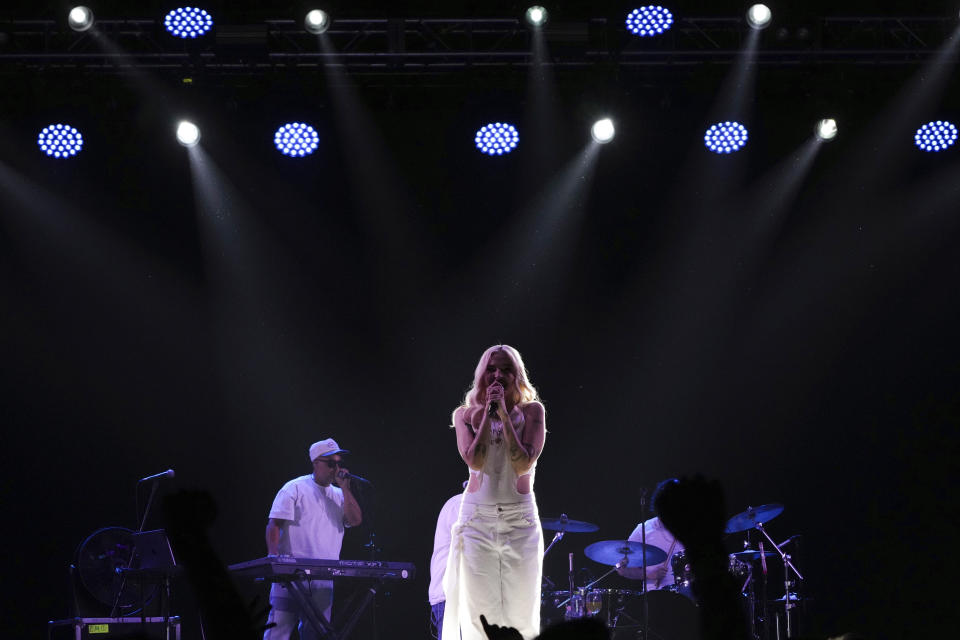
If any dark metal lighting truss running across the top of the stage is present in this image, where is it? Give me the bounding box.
[0,17,957,73]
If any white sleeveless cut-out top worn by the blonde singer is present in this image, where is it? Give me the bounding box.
[463,406,537,505]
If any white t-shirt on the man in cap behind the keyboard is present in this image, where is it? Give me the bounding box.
[270,475,345,560]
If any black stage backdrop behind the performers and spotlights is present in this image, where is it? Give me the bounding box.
[0,3,960,639]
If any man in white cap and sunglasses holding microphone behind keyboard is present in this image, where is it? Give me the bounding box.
[263,438,363,640]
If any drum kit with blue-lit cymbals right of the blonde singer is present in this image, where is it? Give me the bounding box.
[540,504,803,640]
